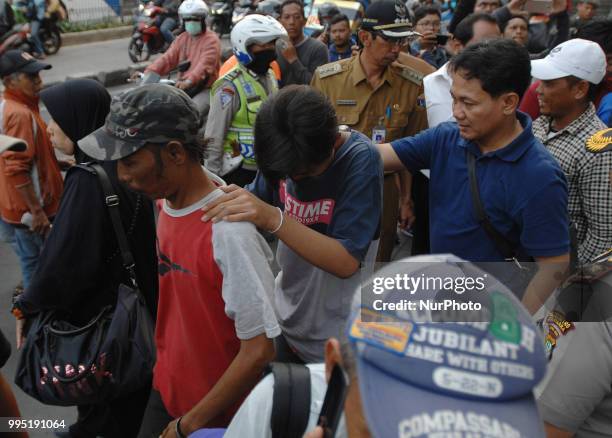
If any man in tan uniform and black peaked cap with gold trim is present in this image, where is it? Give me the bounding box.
[311,0,429,261]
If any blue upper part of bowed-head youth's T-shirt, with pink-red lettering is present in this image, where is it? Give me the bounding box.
[247,131,383,260]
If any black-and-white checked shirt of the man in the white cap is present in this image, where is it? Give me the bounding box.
[533,103,612,263]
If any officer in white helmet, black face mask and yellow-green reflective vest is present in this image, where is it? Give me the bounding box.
[205,14,287,186]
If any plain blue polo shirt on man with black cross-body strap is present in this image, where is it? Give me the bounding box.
[391,112,569,262]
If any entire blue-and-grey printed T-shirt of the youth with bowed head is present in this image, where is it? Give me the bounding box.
[248,131,383,363]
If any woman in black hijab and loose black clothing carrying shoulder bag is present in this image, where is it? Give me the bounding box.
[15,79,157,438]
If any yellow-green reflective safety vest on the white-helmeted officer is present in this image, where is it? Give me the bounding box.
[211,64,278,170]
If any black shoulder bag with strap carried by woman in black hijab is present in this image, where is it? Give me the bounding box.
[15,163,155,406]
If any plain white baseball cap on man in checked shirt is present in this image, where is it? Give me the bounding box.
[531,38,607,84]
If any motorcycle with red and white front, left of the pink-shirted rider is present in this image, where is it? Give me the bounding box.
[128,2,166,62]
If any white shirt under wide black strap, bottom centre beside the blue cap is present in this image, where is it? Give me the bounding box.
[224,363,347,438]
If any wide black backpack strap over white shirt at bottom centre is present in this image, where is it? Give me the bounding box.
[269,362,310,438]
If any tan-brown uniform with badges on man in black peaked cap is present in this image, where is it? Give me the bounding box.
[311,56,428,261]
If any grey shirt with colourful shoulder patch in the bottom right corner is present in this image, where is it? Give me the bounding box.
[535,273,612,438]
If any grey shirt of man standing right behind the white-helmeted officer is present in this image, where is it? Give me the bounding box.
[276,37,329,87]
